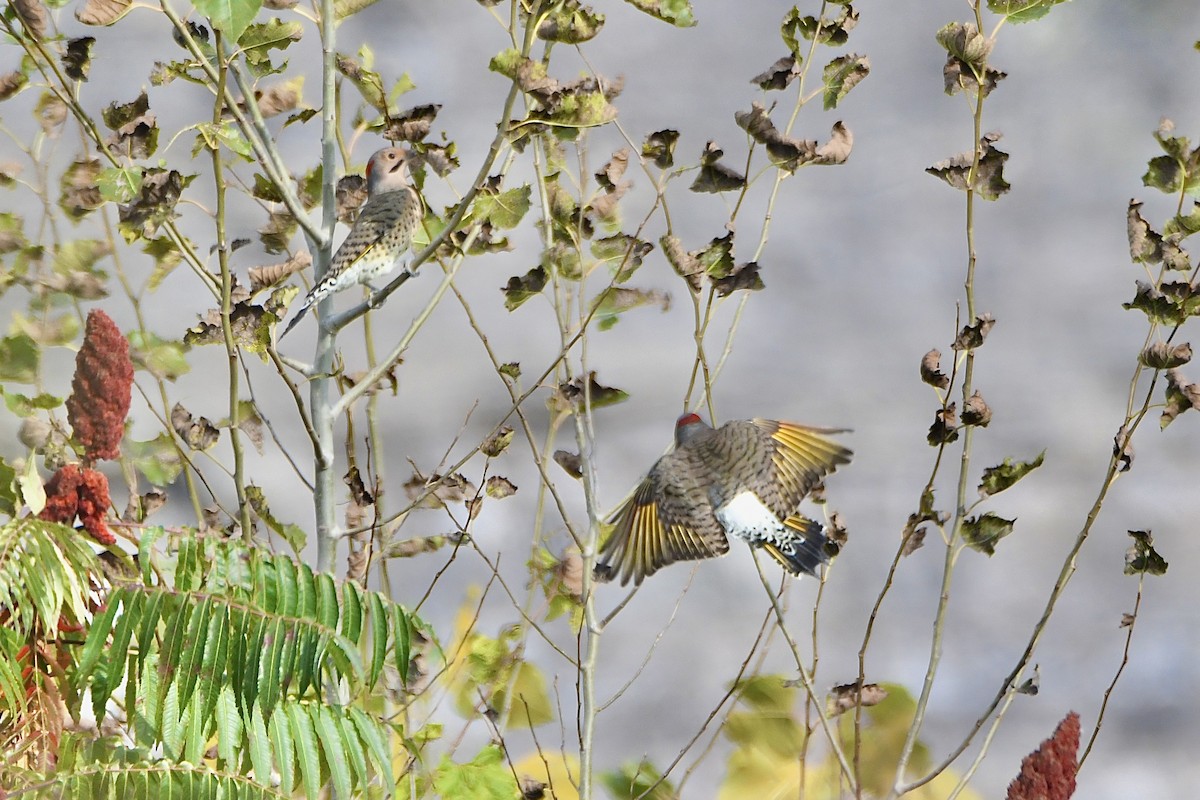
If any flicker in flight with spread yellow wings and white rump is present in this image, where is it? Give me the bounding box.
[596,414,852,584]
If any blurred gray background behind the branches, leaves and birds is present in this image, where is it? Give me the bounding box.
[0,0,1200,800]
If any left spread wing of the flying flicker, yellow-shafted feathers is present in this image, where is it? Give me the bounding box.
[600,473,730,585]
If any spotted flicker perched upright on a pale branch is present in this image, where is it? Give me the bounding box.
[280,148,424,339]
